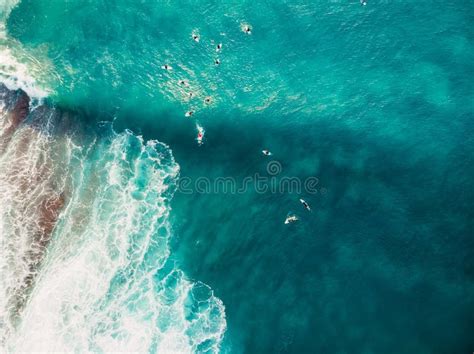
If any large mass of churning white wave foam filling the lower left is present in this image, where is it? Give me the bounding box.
[0,85,226,353]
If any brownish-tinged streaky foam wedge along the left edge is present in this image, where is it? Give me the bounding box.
[0,99,68,343]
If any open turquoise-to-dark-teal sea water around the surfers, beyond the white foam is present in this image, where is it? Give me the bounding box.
[0,0,474,353]
